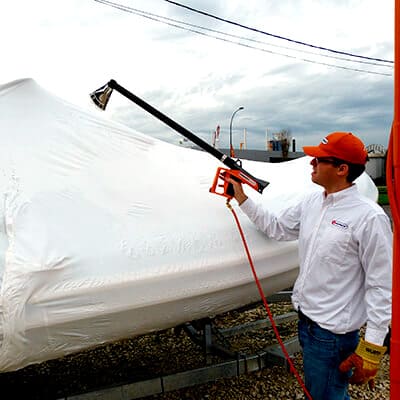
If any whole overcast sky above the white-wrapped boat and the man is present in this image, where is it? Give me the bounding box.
[0,0,394,149]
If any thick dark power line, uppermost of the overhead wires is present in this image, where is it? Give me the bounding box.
[164,0,394,64]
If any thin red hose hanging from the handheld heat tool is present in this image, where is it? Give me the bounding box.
[226,200,312,400]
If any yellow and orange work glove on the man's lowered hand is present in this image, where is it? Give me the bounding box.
[339,339,386,390]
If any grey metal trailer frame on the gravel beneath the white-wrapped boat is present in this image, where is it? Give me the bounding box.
[59,292,301,400]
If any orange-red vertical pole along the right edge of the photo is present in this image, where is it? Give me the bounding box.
[387,0,400,400]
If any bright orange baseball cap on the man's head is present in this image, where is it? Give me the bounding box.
[303,132,368,165]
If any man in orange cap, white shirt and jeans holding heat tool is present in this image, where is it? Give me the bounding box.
[229,132,392,400]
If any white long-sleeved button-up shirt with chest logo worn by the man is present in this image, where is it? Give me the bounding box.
[240,185,393,345]
